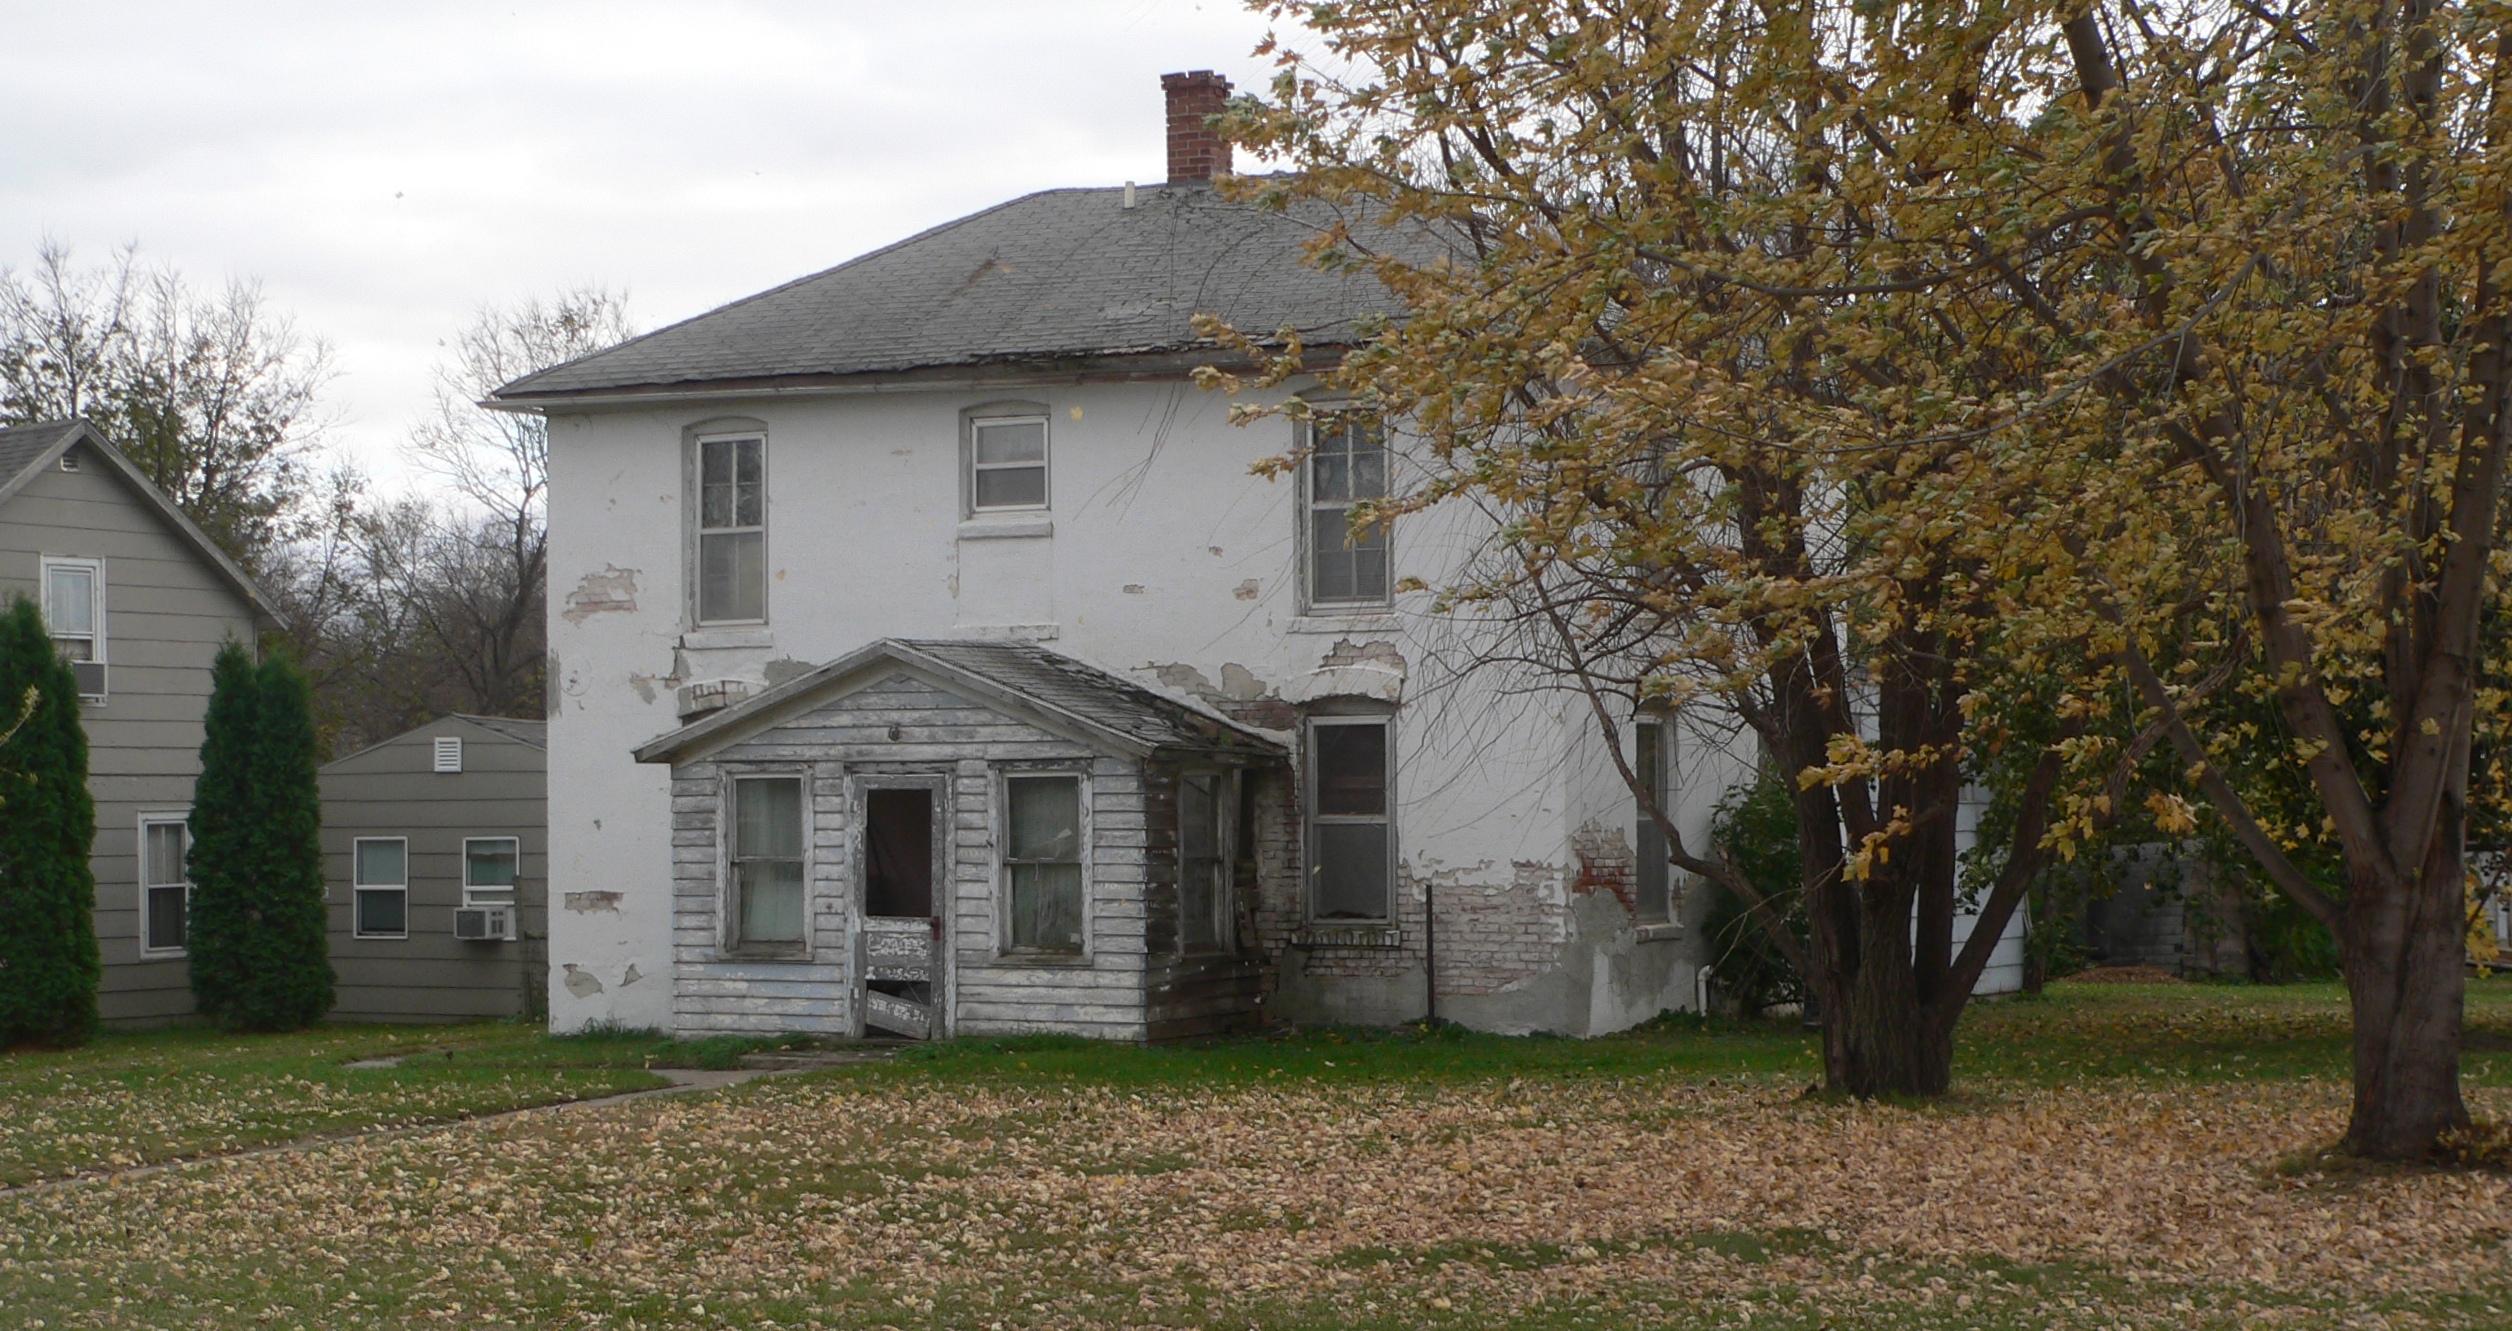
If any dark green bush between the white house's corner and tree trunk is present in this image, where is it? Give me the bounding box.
[1706,773,1806,1015]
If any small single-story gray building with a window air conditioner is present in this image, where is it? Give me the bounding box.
[322,716,550,1022]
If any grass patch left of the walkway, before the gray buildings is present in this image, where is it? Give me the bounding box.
[0,1022,798,1185]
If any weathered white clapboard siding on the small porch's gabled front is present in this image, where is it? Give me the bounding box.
[673,671,1170,1040]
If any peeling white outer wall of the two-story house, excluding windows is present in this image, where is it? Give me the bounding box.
[550,371,1741,1030]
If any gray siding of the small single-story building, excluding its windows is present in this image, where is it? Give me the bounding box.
[322,718,550,1022]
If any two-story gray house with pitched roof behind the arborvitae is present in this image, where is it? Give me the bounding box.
[0,419,279,1025]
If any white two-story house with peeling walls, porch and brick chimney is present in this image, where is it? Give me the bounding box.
[495,73,1743,1037]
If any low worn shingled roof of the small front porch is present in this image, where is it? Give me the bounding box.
[636,638,1281,763]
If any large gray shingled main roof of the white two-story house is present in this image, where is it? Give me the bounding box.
[495,186,1397,402]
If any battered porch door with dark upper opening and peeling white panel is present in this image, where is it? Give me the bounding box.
[857,784,942,1040]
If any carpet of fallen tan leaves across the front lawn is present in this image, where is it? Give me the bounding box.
[0,1077,2512,1326]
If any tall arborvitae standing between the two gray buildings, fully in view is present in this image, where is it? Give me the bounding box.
[191,643,332,1030]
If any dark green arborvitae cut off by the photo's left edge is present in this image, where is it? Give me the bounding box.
[0,598,98,1045]
